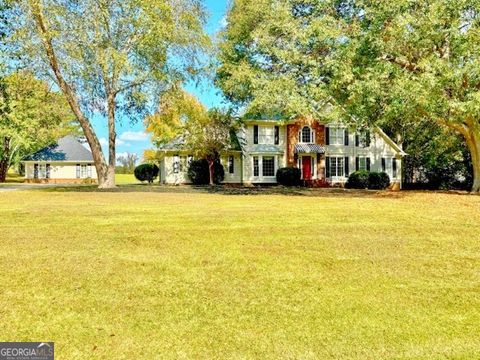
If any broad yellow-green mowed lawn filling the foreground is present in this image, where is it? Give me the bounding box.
[0,187,480,359]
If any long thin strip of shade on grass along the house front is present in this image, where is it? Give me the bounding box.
[33,184,414,199]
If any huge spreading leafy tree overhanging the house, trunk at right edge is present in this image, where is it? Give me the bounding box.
[217,0,480,192]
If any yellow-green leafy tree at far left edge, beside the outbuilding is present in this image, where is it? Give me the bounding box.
[0,72,80,182]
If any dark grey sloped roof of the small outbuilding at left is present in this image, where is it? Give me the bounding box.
[23,135,93,162]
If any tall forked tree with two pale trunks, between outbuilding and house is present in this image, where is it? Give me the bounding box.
[9,0,209,188]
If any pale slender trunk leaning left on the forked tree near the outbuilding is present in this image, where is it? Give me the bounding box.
[31,1,111,188]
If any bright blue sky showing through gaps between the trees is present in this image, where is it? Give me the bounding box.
[97,0,228,158]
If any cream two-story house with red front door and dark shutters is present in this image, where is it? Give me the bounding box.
[156,119,405,188]
